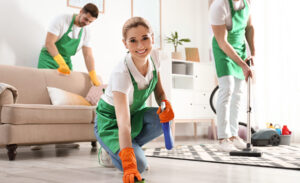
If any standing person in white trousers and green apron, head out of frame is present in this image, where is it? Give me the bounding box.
[210,0,255,152]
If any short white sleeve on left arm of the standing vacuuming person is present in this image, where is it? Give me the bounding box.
[210,0,226,25]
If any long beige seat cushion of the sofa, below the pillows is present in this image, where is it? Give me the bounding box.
[1,104,95,124]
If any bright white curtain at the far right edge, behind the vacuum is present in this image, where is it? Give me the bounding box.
[251,0,300,142]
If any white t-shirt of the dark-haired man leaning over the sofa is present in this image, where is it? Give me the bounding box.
[47,14,91,52]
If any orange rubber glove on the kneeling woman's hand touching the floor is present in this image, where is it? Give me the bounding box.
[119,147,142,183]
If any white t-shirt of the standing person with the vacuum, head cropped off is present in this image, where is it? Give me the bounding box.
[210,0,250,30]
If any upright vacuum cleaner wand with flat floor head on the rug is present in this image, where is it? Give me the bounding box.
[229,60,262,157]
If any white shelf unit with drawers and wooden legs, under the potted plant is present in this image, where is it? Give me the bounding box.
[168,59,216,138]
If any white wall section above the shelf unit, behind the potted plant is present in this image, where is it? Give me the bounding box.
[162,0,209,62]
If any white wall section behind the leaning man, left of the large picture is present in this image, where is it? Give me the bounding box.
[0,0,131,81]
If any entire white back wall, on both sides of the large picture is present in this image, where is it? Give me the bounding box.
[0,0,209,81]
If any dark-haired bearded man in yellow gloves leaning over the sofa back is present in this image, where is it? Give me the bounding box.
[38,3,100,86]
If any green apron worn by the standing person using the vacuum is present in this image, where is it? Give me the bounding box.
[213,0,249,79]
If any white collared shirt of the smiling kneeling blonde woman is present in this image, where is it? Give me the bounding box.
[101,50,160,105]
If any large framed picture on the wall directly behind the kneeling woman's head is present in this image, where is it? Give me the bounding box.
[131,0,162,49]
